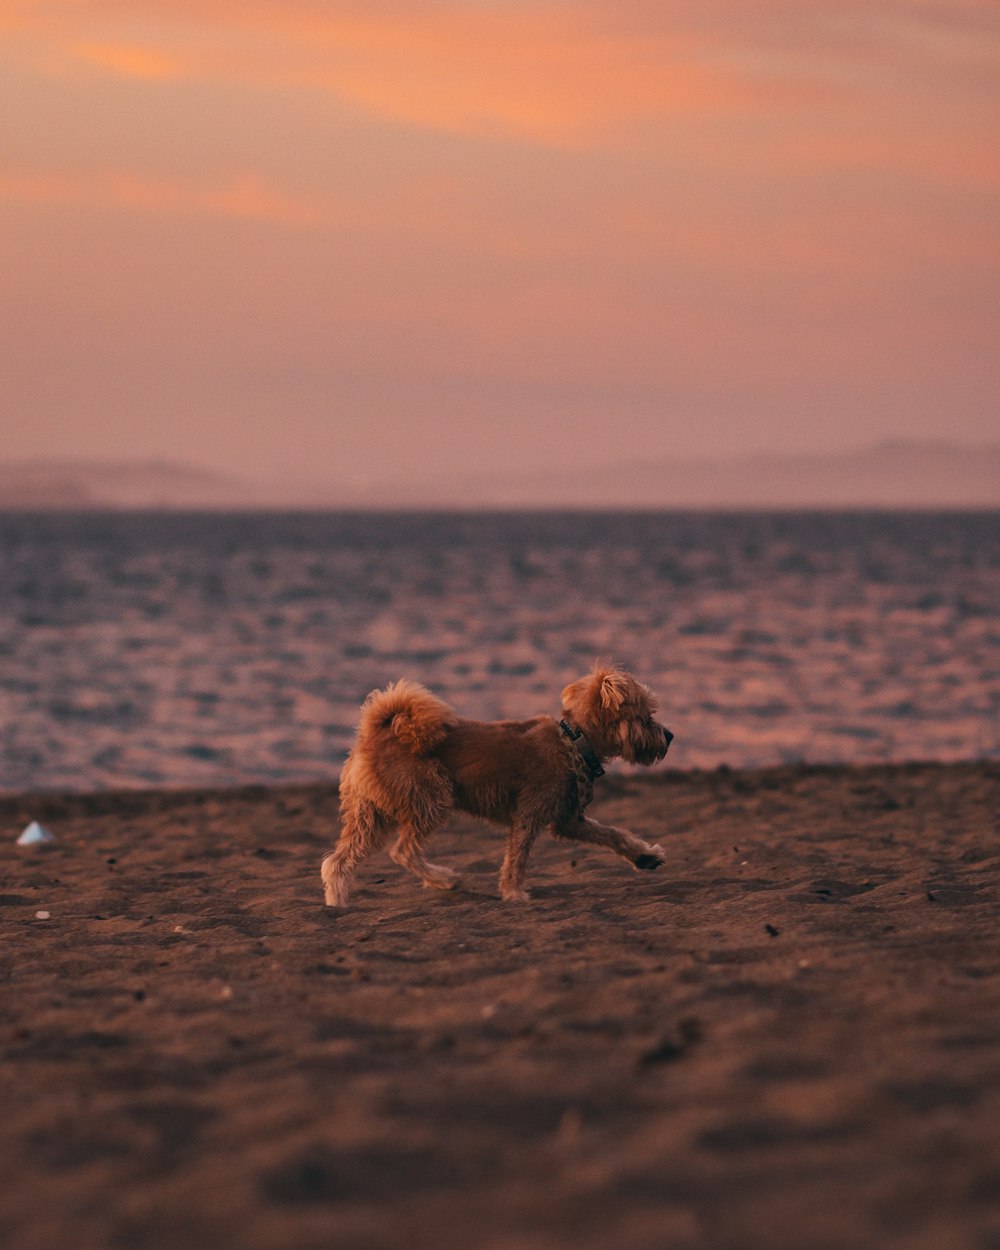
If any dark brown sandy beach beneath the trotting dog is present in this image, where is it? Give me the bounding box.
[0,763,1000,1250]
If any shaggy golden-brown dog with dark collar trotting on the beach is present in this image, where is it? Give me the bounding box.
[321,664,674,908]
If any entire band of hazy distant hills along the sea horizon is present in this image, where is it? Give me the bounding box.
[0,441,1000,509]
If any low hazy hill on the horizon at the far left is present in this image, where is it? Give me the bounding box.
[0,459,264,509]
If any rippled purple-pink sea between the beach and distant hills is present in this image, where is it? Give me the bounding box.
[0,513,1000,791]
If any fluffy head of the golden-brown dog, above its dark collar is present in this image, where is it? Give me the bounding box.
[563,664,674,764]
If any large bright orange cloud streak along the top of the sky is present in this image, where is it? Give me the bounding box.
[7,0,820,145]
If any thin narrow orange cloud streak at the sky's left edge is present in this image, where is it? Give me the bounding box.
[0,170,326,226]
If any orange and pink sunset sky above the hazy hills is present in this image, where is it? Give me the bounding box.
[0,0,1000,481]
